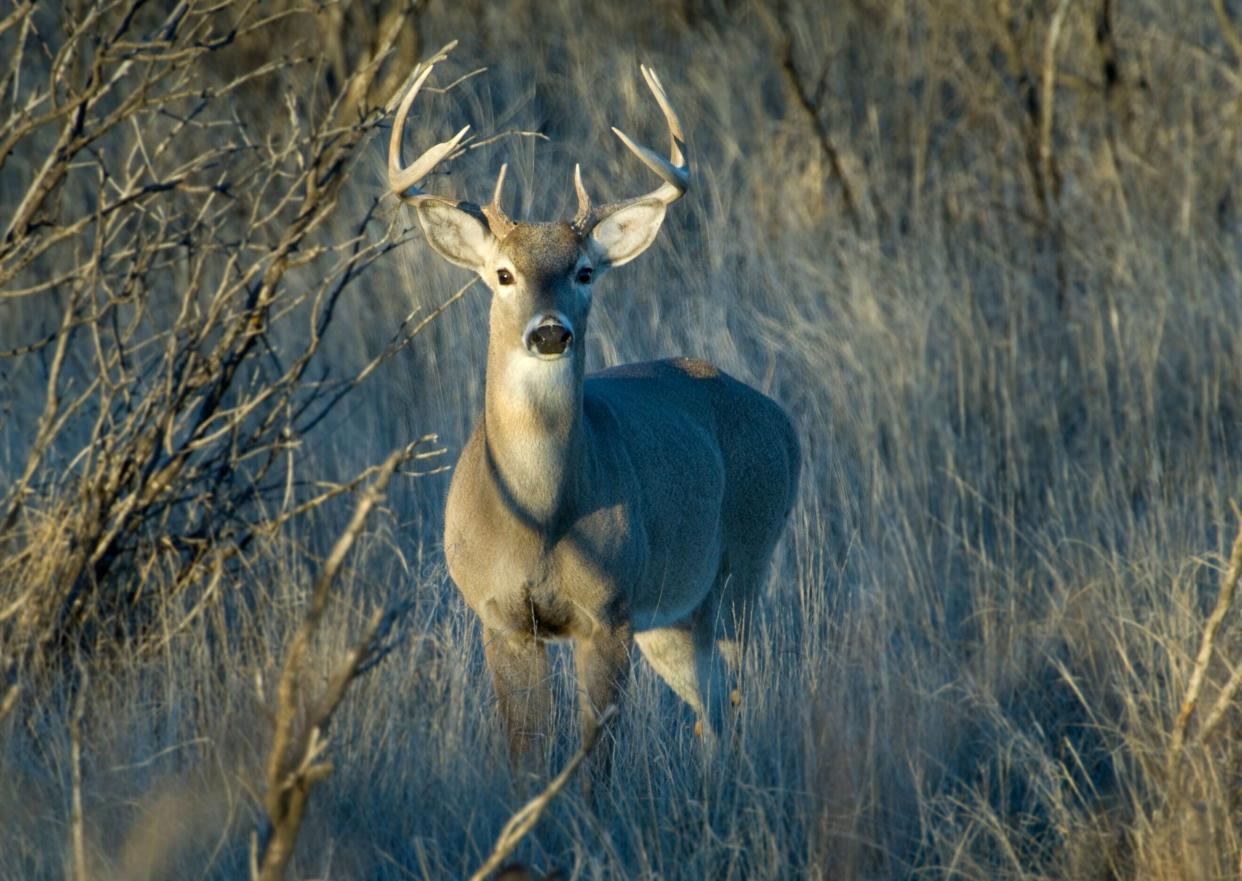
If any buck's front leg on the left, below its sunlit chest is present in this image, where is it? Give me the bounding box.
[483,630,551,770]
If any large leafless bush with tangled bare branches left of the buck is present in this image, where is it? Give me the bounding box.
[0,0,442,680]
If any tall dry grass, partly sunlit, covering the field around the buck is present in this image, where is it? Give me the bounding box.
[0,1,1242,881]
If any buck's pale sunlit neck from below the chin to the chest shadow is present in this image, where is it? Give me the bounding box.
[483,338,586,532]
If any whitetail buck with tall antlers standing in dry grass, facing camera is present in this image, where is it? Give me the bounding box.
[389,49,799,762]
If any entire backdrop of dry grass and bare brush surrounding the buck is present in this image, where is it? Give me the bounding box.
[0,0,1242,881]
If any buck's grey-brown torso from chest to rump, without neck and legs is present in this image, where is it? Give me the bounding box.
[445,350,797,626]
